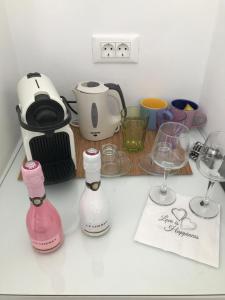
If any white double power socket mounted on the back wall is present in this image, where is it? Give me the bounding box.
[92,34,139,63]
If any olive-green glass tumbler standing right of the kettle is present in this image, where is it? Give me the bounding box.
[121,106,148,152]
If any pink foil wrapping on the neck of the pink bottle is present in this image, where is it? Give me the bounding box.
[21,160,45,198]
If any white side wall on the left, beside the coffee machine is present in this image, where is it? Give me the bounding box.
[0,1,19,177]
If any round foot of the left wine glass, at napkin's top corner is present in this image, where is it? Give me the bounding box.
[149,186,176,206]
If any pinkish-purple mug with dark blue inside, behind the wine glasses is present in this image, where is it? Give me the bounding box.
[171,99,207,128]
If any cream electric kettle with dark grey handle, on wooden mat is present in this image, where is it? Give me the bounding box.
[74,81,126,141]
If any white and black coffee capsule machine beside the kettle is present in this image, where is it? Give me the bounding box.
[16,73,76,184]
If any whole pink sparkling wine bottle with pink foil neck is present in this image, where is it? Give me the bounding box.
[21,161,63,253]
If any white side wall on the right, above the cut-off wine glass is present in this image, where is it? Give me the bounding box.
[201,0,225,133]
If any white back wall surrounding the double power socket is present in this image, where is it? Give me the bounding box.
[5,0,218,103]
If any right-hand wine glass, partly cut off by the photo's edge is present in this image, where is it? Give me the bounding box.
[189,131,225,219]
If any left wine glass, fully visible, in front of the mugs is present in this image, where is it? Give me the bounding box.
[149,122,190,205]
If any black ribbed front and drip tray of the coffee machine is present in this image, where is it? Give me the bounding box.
[29,132,76,184]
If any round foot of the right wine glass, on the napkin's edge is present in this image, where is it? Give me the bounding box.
[189,196,220,219]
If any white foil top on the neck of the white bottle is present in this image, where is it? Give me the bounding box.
[83,148,101,171]
